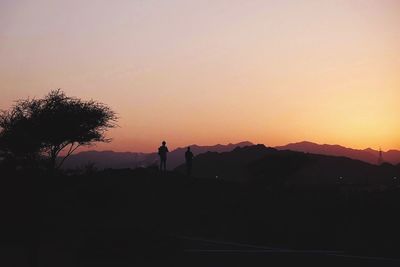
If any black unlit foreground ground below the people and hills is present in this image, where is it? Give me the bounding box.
[0,169,400,266]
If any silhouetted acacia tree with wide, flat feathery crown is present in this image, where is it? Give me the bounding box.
[0,89,117,170]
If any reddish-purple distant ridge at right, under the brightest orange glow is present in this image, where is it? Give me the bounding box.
[275,141,400,164]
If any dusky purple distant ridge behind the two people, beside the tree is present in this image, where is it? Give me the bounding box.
[63,142,253,170]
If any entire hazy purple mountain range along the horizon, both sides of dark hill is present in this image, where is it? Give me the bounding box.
[65,141,400,170]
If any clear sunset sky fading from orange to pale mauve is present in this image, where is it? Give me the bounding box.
[0,0,400,152]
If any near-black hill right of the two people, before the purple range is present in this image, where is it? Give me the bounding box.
[177,145,400,185]
